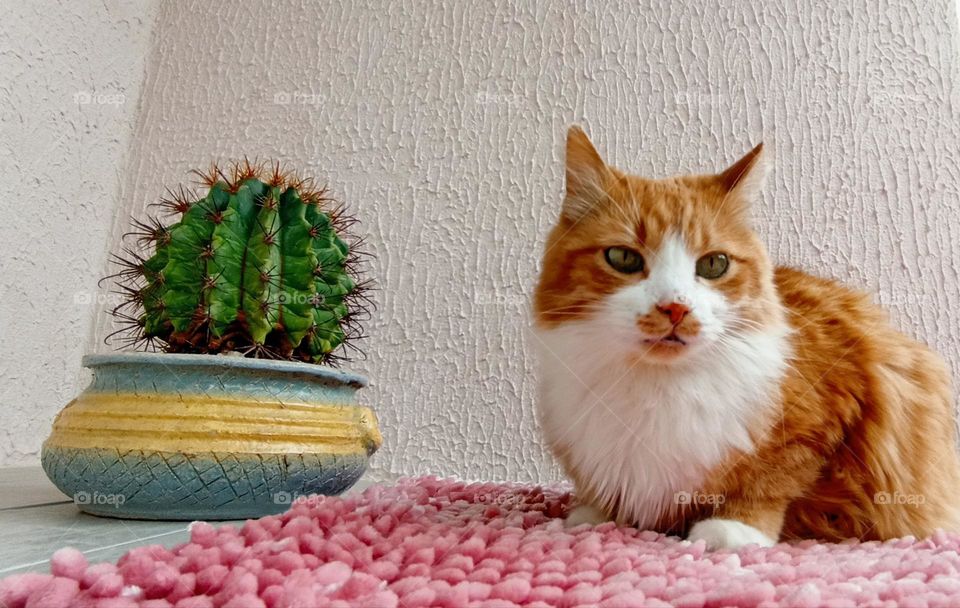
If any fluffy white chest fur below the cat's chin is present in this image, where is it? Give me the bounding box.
[534,323,788,528]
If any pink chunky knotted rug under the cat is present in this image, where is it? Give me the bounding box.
[0,478,960,608]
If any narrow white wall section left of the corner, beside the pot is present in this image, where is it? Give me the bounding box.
[0,0,156,464]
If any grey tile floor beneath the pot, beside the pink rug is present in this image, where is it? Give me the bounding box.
[0,466,382,577]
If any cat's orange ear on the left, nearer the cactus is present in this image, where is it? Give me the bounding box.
[561,125,610,221]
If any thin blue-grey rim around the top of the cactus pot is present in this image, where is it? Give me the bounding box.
[82,352,367,388]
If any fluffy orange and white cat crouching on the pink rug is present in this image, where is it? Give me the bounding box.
[535,127,960,548]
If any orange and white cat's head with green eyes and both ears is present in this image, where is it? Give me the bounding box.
[535,127,782,364]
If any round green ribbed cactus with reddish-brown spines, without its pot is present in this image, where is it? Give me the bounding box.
[108,163,369,364]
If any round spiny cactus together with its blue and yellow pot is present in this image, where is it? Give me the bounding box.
[41,162,381,519]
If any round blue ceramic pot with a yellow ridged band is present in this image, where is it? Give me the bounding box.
[41,353,382,520]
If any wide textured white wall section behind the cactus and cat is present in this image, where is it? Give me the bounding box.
[79,0,960,479]
